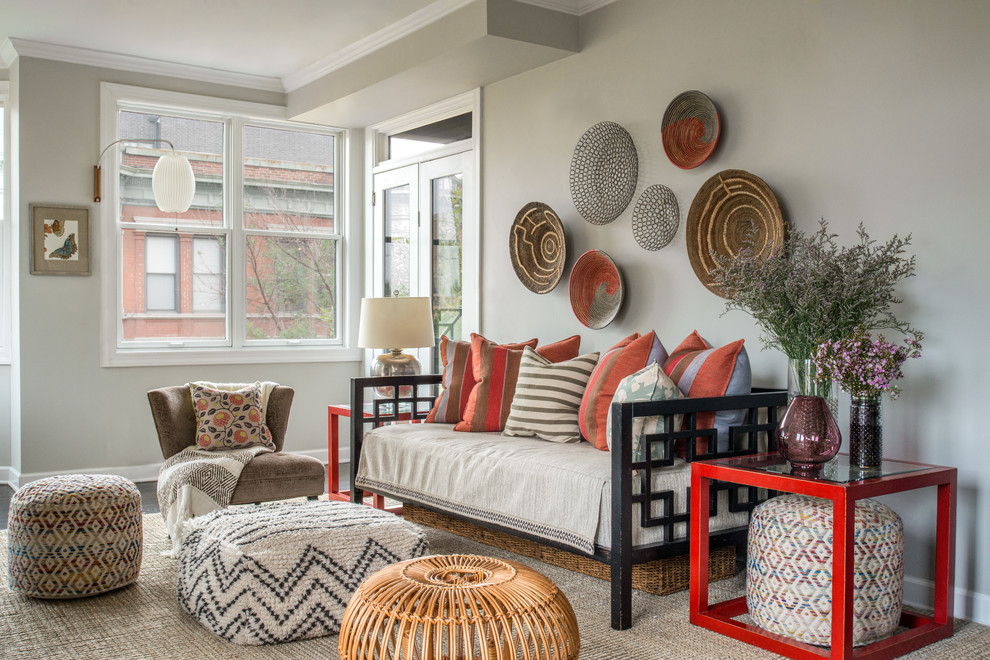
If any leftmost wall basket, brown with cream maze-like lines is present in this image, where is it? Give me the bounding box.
[509,202,567,293]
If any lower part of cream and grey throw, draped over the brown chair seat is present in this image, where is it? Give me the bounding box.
[158,447,271,557]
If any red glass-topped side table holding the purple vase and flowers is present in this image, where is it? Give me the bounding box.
[690,453,956,660]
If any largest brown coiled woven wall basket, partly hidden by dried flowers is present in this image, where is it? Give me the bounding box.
[685,170,785,298]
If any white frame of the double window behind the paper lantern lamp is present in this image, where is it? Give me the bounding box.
[99,83,361,367]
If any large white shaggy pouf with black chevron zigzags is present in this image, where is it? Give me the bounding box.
[178,501,429,645]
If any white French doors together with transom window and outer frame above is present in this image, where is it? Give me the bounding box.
[365,90,481,373]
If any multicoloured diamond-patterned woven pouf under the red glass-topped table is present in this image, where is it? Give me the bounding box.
[746,494,904,646]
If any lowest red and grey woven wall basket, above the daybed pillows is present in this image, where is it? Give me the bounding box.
[568,250,624,330]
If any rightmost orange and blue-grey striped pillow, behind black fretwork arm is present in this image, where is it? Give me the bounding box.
[663,330,753,452]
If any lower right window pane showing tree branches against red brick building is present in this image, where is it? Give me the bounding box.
[245,236,337,339]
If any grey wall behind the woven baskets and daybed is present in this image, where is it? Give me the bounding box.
[482,0,990,621]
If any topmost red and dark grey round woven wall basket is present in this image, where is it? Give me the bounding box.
[661,91,721,170]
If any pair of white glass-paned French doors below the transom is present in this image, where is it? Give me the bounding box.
[372,151,477,373]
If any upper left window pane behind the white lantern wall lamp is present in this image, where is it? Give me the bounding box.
[118,111,224,227]
